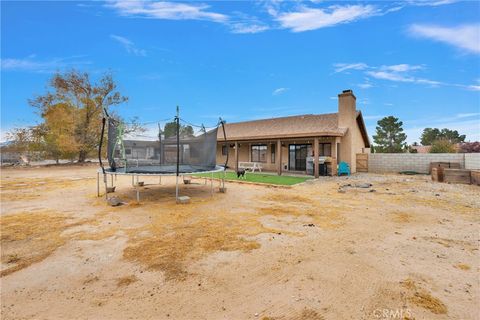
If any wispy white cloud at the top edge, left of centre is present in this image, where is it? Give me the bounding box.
[107,1,228,22]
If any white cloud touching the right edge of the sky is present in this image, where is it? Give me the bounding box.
[408,24,480,54]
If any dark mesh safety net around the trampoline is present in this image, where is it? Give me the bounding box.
[107,118,218,174]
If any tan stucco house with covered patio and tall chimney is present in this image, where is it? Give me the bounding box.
[217,90,370,177]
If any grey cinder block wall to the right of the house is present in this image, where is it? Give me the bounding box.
[368,153,464,173]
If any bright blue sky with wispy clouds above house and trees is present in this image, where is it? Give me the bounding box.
[1,0,480,142]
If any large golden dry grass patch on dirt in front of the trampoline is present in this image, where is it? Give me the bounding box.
[124,204,278,280]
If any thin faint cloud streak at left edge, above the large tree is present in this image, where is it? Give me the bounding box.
[1,55,91,73]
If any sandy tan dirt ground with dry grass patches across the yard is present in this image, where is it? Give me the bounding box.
[0,166,480,320]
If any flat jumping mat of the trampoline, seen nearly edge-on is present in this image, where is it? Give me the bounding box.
[106,164,223,175]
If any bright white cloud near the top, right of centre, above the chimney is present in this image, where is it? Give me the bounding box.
[272,5,378,32]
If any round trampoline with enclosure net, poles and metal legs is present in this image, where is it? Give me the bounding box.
[97,107,228,202]
